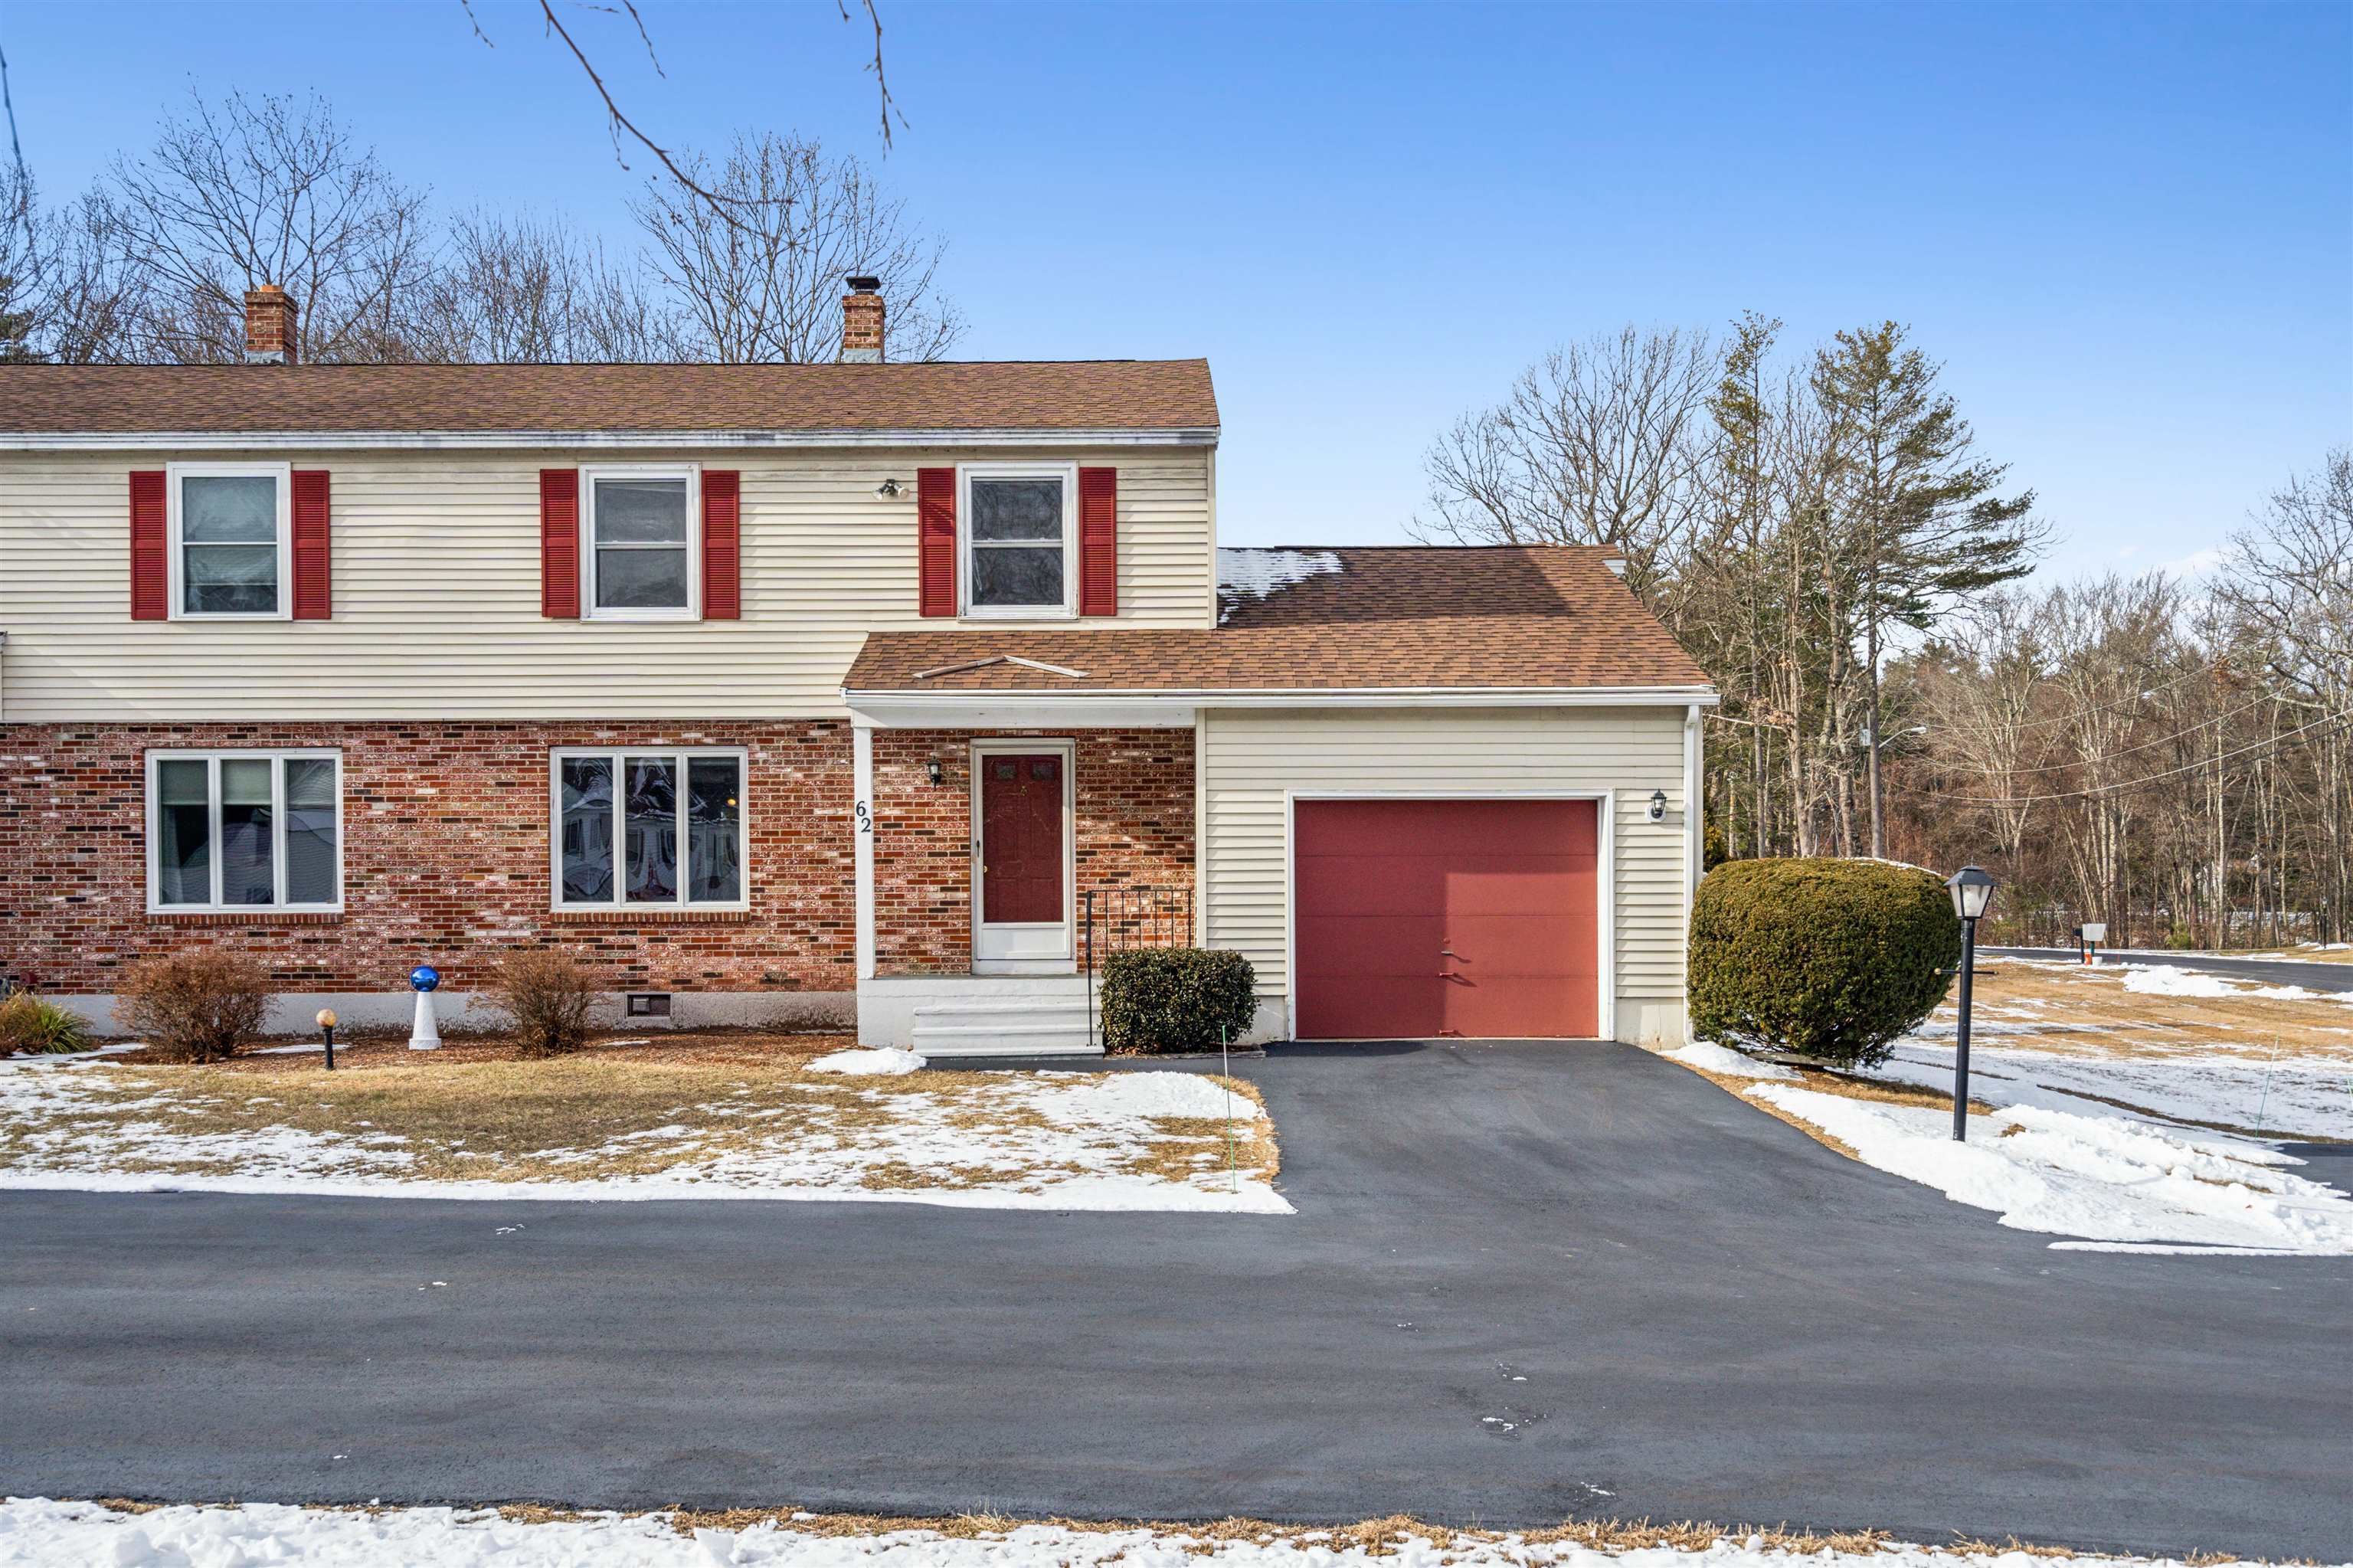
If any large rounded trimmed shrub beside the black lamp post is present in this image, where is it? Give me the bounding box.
[1692,859,1960,1066]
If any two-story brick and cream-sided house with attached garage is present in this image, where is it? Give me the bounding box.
[0,280,1713,1055]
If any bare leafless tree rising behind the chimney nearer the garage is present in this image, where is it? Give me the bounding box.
[630,132,965,365]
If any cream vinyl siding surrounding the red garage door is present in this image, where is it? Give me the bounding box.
[1200,706,1687,1041]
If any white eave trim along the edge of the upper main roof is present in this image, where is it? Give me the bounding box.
[0,424,1216,452]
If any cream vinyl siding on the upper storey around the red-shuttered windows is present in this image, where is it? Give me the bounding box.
[0,447,1216,723]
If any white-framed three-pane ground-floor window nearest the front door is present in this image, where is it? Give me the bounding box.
[548,746,751,908]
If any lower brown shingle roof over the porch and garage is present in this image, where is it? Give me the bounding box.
[843,546,1708,692]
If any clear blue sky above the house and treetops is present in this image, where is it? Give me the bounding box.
[0,0,2353,574]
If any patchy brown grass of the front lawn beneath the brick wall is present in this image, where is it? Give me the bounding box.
[0,1033,1278,1189]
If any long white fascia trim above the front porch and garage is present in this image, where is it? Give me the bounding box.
[843,685,1718,730]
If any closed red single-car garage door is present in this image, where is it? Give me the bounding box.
[1292,800,1600,1041]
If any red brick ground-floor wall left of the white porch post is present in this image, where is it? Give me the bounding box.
[0,721,856,994]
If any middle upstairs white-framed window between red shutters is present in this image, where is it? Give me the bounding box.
[581,463,704,621]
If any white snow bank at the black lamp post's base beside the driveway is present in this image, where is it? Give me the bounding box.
[1748,1083,2353,1255]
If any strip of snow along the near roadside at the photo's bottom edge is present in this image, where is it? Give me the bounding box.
[0,1498,2325,1568]
